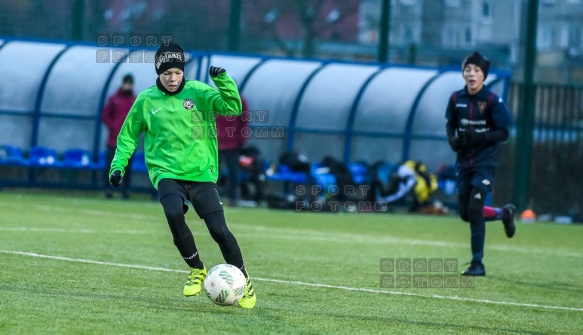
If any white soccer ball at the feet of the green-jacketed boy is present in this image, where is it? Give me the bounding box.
[204,264,247,306]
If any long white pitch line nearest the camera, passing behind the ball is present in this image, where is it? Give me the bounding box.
[0,250,583,312]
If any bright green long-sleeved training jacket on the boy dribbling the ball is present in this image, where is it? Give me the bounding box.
[109,73,242,189]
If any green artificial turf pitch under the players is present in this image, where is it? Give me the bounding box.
[0,189,583,335]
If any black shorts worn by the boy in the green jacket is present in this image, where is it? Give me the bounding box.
[158,178,223,219]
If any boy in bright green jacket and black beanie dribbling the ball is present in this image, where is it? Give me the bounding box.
[109,43,257,308]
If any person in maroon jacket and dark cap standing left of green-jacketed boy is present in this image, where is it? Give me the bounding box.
[101,74,136,199]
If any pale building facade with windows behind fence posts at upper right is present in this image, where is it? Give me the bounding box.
[358,0,583,83]
